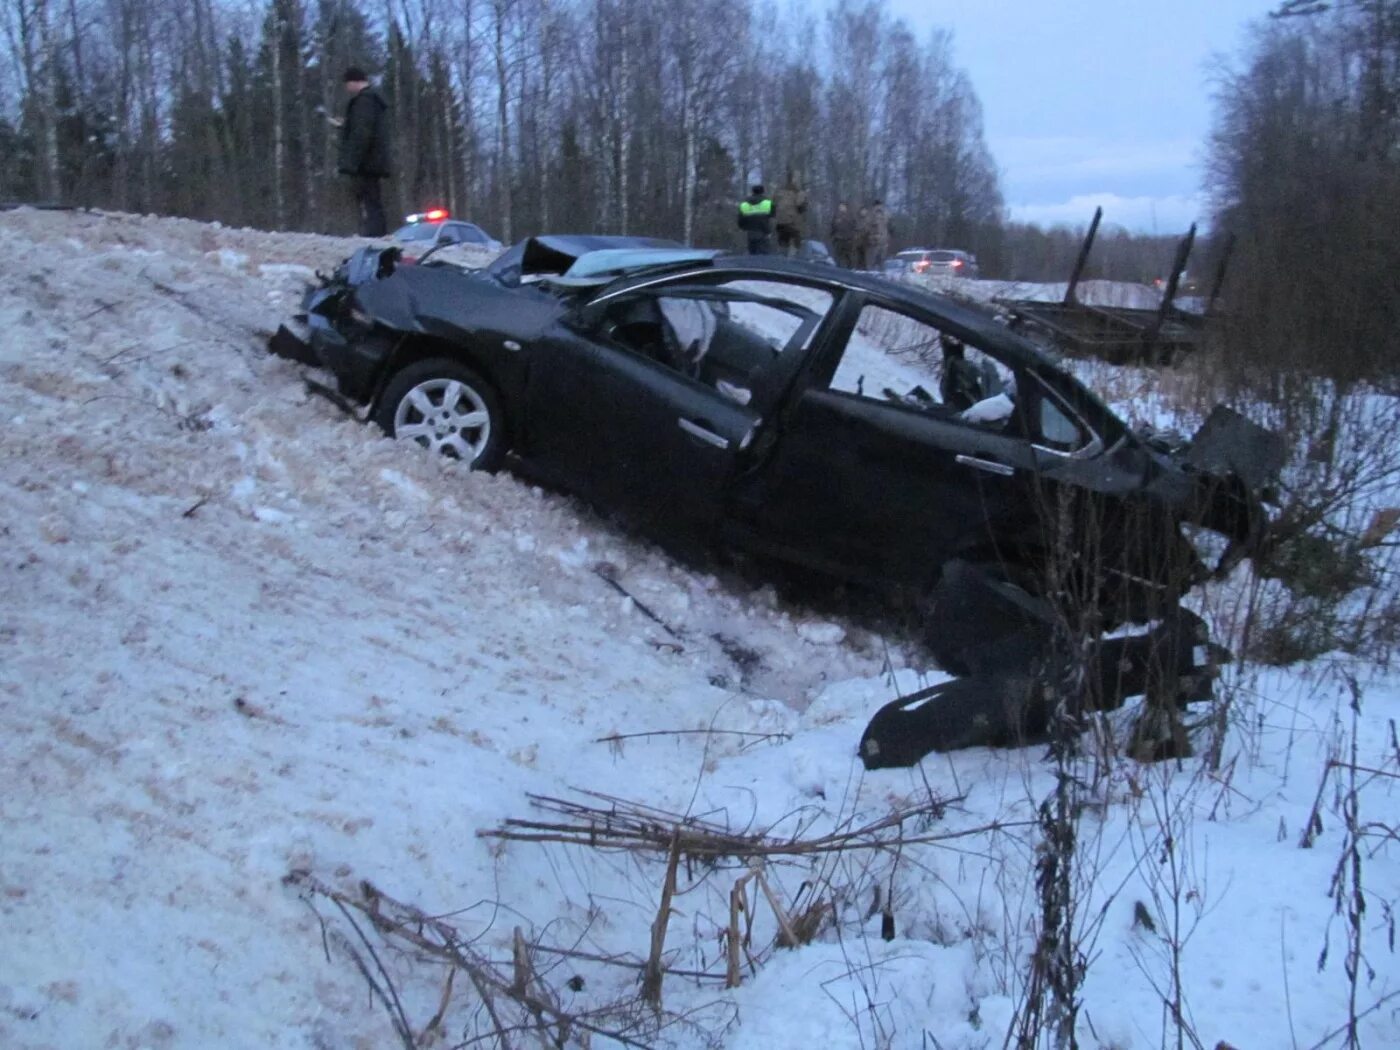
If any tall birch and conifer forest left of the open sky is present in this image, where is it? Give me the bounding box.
[0,0,1002,263]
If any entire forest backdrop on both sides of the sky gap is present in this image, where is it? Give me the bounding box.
[10,0,1366,299]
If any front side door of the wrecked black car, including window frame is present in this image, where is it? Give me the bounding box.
[526,270,832,526]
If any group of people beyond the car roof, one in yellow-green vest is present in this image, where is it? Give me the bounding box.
[738,171,889,270]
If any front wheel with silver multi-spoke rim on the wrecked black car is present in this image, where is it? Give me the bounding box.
[374,357,505,470]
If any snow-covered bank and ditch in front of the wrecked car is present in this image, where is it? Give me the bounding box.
[0,211,1400,1050]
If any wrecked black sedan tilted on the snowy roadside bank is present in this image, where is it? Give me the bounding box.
[273,237,1281,764]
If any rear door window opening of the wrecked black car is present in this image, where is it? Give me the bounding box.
[829,304,1015,428]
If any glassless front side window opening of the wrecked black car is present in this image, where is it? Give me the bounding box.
[601,280,833,405]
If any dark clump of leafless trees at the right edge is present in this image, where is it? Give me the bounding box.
[1210,0,1400,381]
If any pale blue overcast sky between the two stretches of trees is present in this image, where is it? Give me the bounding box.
[889,0,1277,234]
